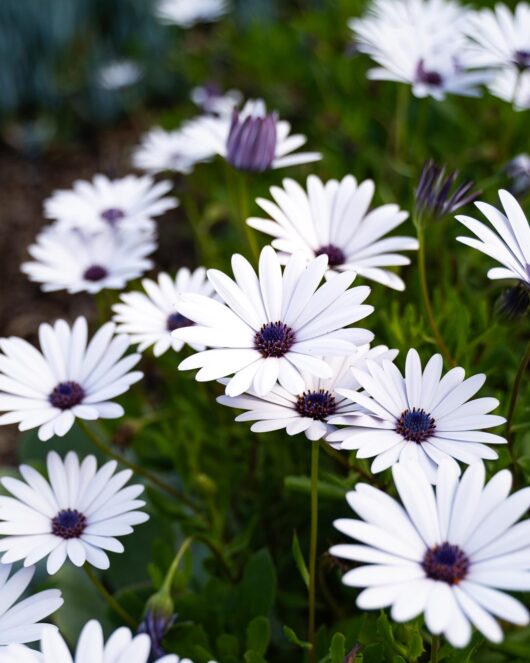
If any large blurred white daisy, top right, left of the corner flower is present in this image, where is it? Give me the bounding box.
[349,0,491,101]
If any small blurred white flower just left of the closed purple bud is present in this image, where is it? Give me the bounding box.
[132,117,216,174]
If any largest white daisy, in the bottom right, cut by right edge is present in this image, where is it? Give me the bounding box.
[330,462,530,647]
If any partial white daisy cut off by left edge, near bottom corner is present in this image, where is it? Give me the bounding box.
[0,564,63,660]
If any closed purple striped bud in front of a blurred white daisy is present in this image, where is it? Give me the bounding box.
[226,110,278,173]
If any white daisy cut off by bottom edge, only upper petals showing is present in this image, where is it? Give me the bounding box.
[0,619,186,663]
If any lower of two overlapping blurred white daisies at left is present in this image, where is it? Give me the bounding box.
[20,226,157,294]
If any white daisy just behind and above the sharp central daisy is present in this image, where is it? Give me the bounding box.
[247,175,418,290]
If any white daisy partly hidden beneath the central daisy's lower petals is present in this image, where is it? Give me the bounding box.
[217,345,398,440]
